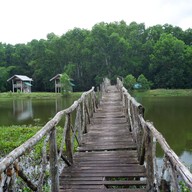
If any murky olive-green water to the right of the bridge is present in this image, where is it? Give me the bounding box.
[137,97,192,171]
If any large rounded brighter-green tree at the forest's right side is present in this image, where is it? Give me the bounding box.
[149,33,186,88]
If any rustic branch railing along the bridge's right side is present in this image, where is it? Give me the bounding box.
[117,79,192,192]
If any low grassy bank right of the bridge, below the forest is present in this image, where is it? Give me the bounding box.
[132,89,192,97]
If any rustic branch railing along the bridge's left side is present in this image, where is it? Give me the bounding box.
[0,87,97,192]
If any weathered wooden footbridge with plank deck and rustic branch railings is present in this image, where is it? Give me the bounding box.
[0,79,192,192]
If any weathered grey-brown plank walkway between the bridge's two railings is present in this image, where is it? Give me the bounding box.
[60,86,147,192]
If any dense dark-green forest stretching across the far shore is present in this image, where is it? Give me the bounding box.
[0,21,192,92]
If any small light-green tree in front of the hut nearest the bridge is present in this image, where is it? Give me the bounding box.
[60,73,72,96]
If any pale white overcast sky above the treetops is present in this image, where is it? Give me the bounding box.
[0,0,192,45]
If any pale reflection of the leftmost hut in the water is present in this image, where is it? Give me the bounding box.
[13,99,33,121]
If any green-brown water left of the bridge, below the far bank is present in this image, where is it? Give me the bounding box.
[0,97,78,126]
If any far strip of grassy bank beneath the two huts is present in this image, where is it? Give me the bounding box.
[0,92,82,99]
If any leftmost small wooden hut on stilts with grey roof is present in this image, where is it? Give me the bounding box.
[7,75,33,93]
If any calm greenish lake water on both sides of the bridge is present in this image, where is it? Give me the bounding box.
[0,97,192,171]
